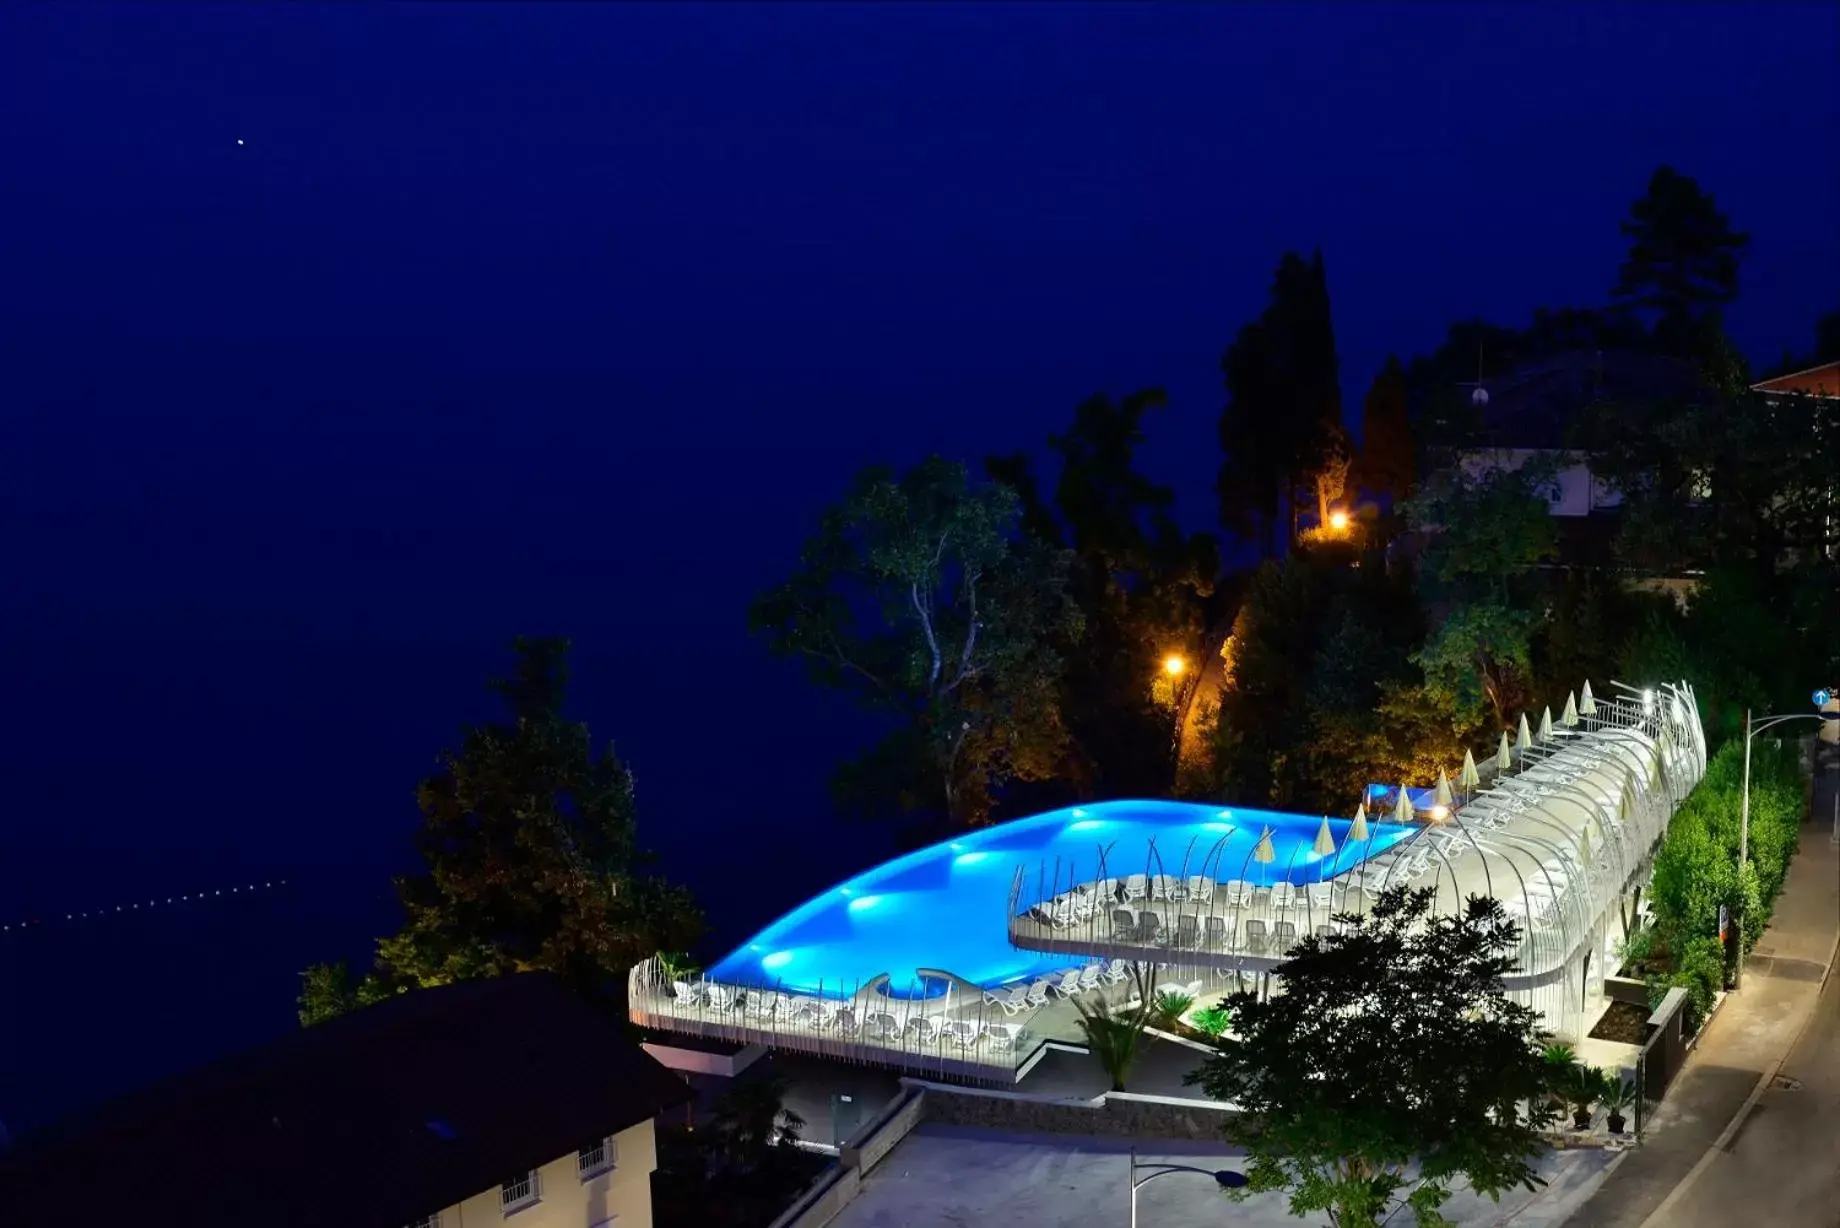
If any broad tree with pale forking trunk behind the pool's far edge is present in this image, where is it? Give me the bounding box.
[753,457,1080,825]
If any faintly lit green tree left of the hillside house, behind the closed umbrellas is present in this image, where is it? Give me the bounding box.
[1406,462,1557,724]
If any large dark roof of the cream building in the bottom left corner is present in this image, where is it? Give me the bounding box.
[0,974,692,1228]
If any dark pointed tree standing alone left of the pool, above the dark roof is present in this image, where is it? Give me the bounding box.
[300,639,703,1024]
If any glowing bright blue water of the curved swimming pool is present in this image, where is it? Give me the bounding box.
[708,801,1411,996]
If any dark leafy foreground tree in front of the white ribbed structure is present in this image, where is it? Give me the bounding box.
[1190,887,1553,1228]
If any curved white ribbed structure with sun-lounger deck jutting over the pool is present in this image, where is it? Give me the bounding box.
[1008,683,1706,1037]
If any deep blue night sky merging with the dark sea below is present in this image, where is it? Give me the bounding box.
[0,2,1840,1123]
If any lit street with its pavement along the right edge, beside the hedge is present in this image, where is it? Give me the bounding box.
[1566,771,1840,1228]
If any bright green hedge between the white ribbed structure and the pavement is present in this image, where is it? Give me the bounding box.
[1649,740,1807,1016]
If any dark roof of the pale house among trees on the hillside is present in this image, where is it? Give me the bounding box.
[1481,350,1709,447]
